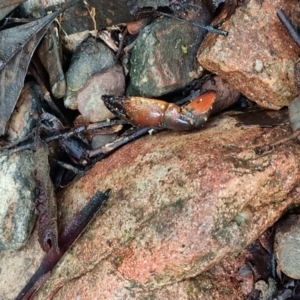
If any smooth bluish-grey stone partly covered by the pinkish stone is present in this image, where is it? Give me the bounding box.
[64,37,116,109]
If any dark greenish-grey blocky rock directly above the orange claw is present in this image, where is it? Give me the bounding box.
[127,9,210,97]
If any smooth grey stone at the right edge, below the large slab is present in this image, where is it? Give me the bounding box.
[275,215,300,279]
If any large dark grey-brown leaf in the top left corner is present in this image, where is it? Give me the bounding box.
[0,0,78,135]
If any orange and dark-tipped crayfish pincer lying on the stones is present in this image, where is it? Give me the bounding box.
[102,91,216,130]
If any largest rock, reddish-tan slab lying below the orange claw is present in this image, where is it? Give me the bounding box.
[29,112,300,300]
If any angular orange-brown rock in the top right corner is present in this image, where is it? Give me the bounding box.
[198,0,300,109]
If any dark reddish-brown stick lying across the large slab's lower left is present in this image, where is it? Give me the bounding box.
[16,190,110,300]
